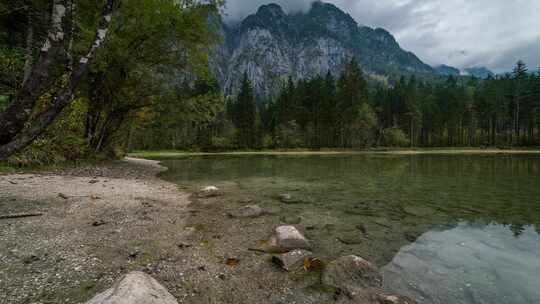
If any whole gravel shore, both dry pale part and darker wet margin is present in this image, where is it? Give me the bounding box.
[0,159,346,304]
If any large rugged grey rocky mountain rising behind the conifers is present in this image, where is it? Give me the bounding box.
[210,2,436,96]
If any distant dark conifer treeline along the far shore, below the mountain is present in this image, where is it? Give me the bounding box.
[132,59,540,150]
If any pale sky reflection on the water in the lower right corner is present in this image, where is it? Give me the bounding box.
[383,223,540,304]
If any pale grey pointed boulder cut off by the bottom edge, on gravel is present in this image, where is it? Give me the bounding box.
[86,271,178,304]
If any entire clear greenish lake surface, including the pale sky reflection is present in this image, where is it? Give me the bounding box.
[155,154,540,304]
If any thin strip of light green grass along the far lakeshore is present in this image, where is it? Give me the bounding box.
[129,147,540,158]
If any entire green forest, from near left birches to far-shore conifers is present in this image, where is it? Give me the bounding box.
[0,0,540,164]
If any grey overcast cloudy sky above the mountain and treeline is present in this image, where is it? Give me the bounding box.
[226,0,540,72]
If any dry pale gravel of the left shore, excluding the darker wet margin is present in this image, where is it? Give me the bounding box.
[0,159,194,303]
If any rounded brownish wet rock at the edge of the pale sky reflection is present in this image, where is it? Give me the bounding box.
[322,255,382,295]
